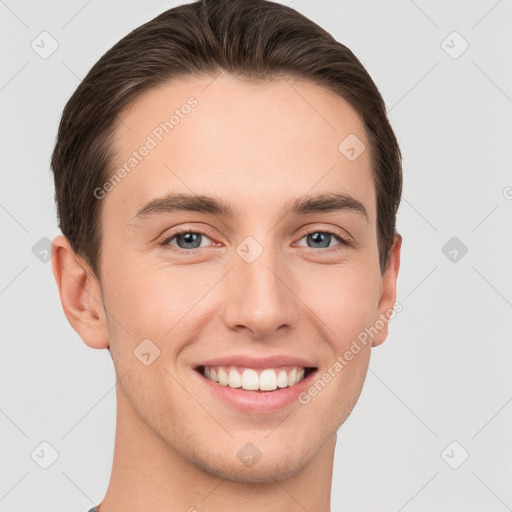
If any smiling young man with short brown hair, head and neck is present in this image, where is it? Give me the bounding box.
[52,0,402,512]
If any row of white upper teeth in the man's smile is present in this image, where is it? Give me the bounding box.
[203,366,305,391]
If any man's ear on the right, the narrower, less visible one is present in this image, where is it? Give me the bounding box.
[372,233,402,347]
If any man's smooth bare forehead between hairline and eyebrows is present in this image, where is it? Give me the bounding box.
[104,74,375,222]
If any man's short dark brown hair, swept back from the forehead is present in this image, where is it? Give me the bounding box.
[51,0,402,278]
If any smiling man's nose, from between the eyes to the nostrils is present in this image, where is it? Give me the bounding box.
[224,240,300,341]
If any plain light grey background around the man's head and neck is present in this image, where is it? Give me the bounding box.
[0,0,512,512]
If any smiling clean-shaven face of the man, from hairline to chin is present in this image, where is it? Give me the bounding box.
[84,75,397,482]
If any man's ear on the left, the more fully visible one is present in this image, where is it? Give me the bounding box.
[52,235,109,348]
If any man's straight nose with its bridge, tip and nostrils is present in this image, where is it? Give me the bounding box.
[225,236,297,337]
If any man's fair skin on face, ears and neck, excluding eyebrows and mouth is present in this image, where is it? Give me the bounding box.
[52,74,401,512]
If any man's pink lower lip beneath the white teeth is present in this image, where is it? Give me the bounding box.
[193,370,316,414]
